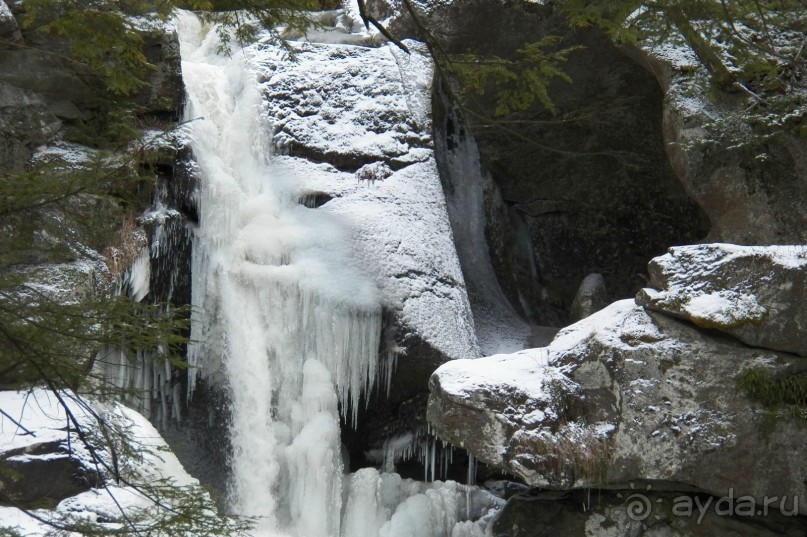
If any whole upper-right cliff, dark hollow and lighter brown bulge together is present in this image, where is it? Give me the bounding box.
[378,0,807,314]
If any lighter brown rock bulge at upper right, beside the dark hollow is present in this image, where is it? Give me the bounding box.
[623,45,807,245]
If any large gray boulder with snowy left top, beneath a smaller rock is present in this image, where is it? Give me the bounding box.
[428,300,807,514]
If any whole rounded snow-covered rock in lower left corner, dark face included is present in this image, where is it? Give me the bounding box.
[0,389,212,536]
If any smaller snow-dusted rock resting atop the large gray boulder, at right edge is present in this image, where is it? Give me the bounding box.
[636,244,807,356]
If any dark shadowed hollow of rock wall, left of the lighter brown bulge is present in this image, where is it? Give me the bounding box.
[370,0,709,316]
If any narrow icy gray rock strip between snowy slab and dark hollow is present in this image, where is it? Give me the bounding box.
[435,90,544,355]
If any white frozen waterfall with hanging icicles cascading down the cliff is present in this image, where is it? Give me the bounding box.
[177,13,498,537]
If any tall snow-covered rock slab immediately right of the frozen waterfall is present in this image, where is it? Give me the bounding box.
[252,36,478,397]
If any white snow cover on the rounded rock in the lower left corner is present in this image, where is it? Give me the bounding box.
[0,389,212,537]
